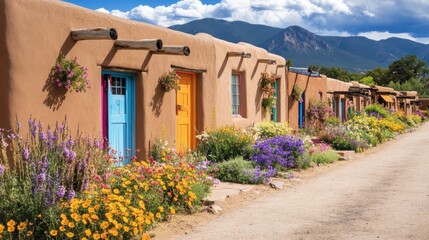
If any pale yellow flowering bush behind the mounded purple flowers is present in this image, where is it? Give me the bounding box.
[253,121,292,139]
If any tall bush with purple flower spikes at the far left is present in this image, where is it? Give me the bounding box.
[0,119,112,239]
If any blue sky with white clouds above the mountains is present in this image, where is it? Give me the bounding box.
[61,0,429,44]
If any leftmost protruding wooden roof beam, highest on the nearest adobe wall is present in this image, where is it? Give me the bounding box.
[70,27,118,41]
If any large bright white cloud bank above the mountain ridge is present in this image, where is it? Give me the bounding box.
[97,0,352,27]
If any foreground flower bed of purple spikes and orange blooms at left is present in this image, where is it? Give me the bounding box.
[0,120,213,239]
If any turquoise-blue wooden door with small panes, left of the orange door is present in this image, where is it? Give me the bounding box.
[103,71,135,165]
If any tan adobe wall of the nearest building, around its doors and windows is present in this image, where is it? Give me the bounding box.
[0,0,286,157]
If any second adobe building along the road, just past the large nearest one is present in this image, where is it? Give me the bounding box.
[286,67,327,129]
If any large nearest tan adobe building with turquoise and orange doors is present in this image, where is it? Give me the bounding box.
[0,0,288,161]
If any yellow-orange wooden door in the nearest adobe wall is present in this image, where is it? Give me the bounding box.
[176,72,195,152]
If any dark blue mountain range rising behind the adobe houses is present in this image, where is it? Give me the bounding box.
[170,18,429,72]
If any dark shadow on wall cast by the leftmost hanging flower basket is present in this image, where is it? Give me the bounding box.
[42,66,67,111]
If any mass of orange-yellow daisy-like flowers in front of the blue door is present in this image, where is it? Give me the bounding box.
[49,159,212,239]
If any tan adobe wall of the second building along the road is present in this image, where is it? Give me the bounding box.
[287,72,327,129]
